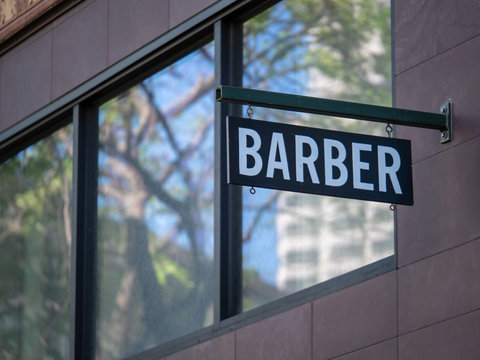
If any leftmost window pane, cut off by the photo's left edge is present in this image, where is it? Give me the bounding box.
[0,126,72,360]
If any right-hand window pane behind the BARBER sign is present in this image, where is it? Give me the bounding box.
[243,0,394,310]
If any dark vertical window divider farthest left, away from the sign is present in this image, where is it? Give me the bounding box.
[70,104,98,360]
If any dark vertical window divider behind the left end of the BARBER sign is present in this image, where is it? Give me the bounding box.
[214,19,243,324]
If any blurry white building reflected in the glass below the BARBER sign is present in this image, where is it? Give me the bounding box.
[276,192,393,293]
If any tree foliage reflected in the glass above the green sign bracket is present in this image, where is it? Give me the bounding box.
[244,0,391,105]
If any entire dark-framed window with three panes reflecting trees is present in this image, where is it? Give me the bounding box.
[0,0,396,360]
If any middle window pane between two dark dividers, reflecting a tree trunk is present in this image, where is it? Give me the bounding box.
[97,44,214,359]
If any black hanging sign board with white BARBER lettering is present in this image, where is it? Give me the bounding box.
[227,116,413,205]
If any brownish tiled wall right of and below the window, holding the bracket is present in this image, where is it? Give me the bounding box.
[158,0,480,360]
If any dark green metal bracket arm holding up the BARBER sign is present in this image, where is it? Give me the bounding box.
[215,85,452,143]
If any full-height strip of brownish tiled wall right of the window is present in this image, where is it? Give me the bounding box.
[395,0,480,359]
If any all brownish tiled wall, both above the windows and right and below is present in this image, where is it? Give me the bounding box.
[0,0,480,360]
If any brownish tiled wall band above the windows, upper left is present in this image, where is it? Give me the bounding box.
[0,0,215,132]
